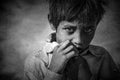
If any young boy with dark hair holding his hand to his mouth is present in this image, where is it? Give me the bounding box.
[25,0,120,80]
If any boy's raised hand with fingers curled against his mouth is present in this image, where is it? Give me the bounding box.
[49,40,77,74]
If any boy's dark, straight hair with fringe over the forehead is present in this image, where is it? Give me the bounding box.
[48,0,106,28]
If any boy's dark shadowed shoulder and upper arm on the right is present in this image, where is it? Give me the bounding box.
[90,45,120,80]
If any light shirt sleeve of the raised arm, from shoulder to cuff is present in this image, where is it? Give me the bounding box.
[24,52,62,80]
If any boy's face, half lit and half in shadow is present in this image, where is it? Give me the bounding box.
[56,21,96,50]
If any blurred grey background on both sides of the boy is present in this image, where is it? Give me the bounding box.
[0,0,120,80]
